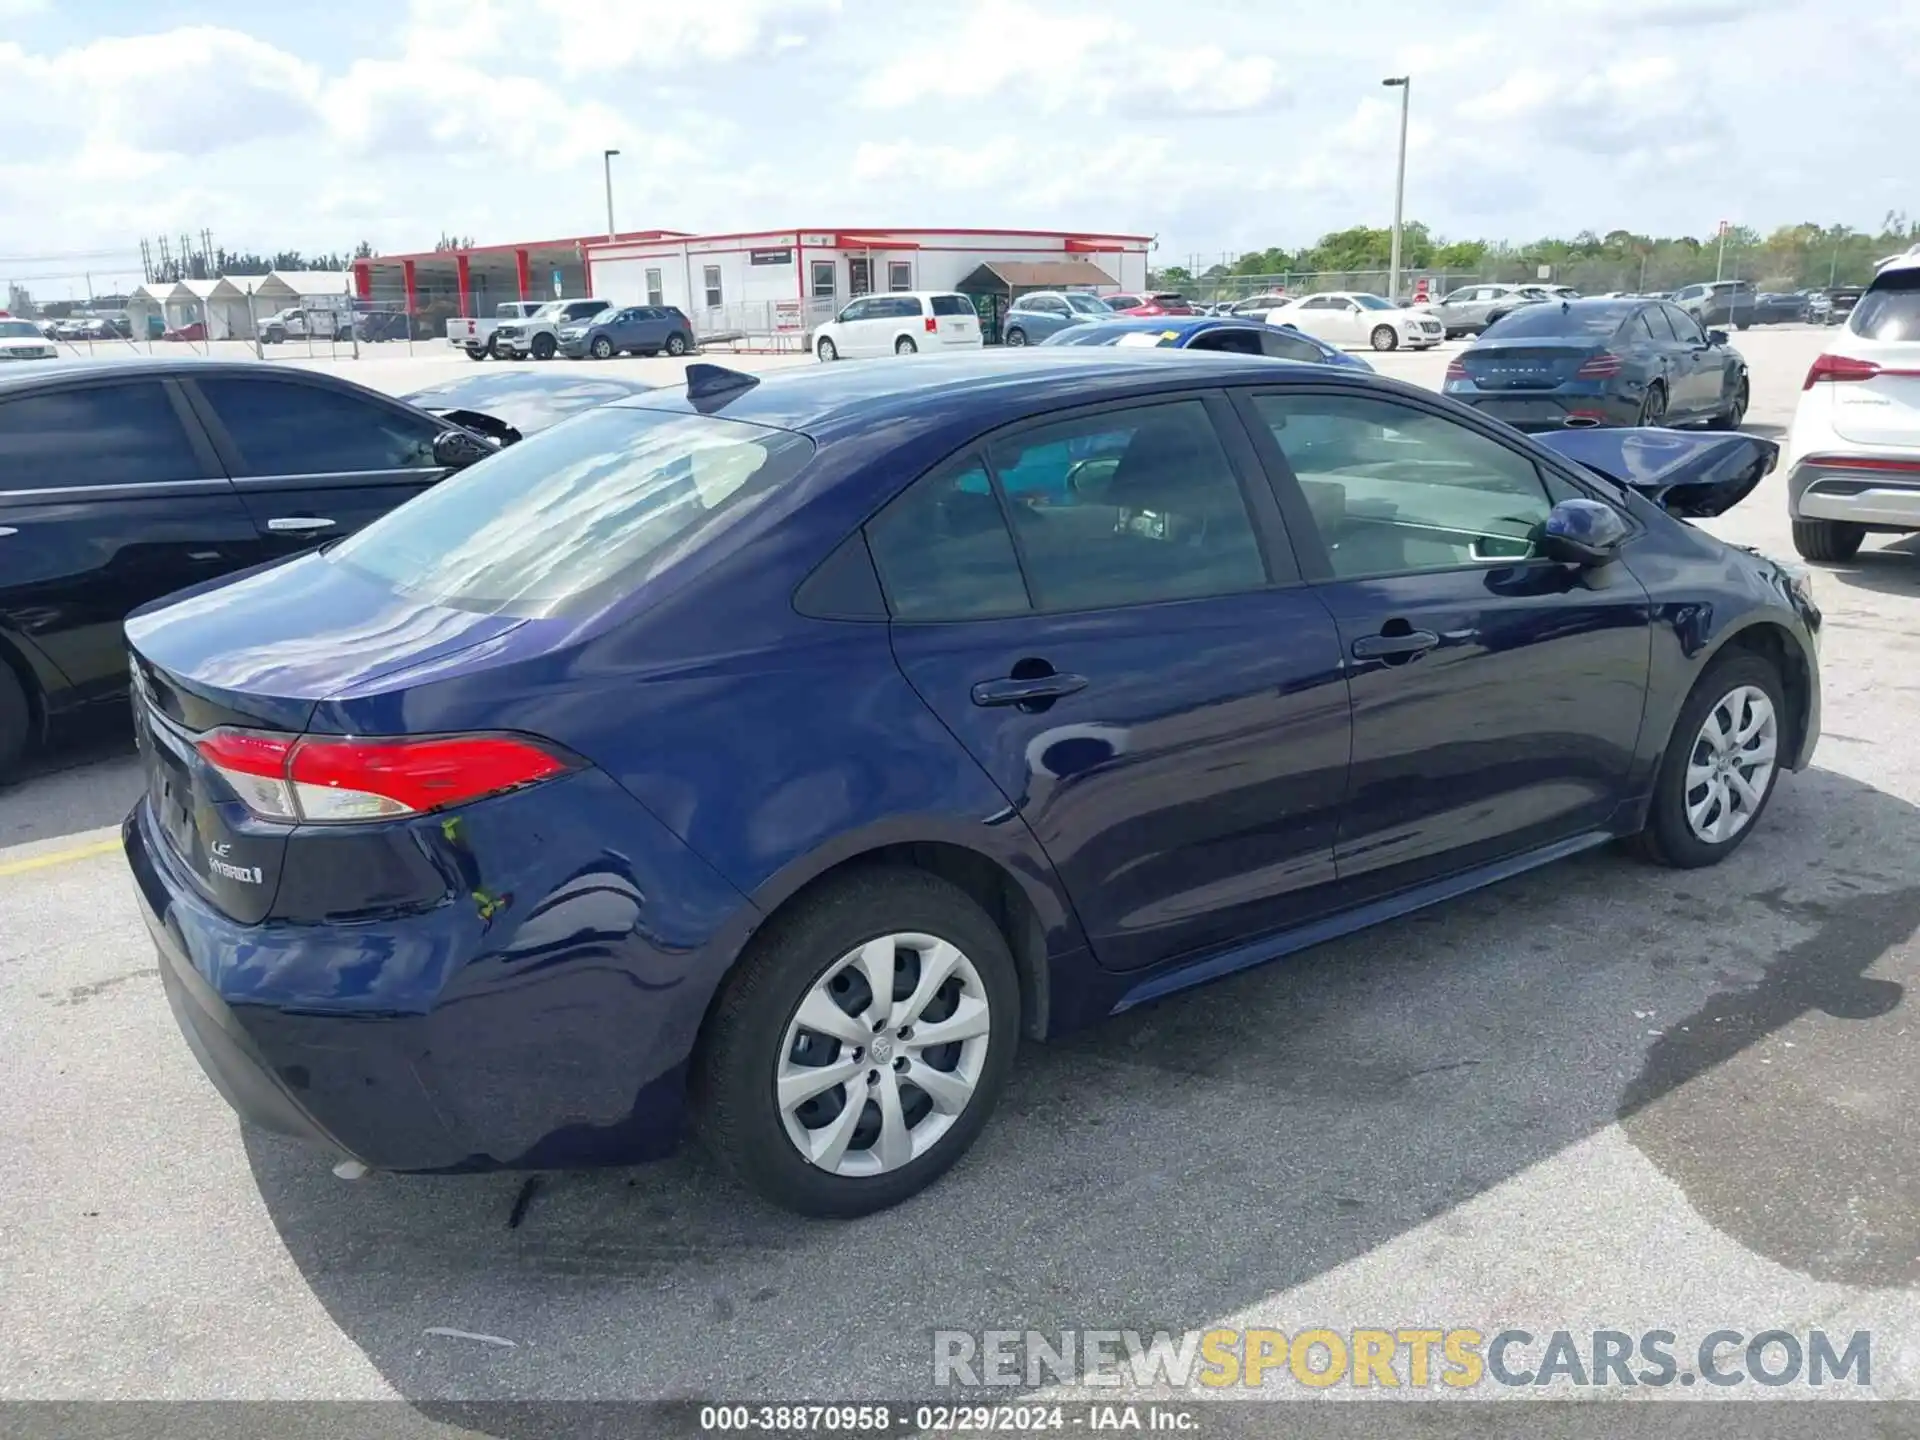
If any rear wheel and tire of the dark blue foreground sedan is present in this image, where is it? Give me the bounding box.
[693,868,1020,1217]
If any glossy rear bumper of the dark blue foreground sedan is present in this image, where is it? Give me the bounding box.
[121,772,751,1171]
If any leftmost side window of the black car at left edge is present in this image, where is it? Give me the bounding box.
[0,380,207,492]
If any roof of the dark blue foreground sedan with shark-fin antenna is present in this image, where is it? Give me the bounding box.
[611,351,1404,444]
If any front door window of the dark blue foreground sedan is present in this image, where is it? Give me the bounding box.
[1254,394,1551,580]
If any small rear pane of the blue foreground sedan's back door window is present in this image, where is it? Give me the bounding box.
[866,459,1029,620]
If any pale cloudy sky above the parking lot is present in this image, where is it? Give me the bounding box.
[0,0,1920,300]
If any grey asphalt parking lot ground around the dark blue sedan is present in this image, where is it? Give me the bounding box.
[0,328,1920,1434]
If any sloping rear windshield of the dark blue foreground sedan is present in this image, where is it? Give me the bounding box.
[326,409,814,618]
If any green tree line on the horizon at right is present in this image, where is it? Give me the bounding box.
[1152,211,1920,296]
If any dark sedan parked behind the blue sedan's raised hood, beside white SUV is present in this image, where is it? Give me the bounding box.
[1444,300,1747,430]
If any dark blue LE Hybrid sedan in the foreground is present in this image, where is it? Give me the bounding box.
[123,348,1820,1215]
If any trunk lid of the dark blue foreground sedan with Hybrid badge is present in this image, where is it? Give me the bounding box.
[127,555,524,924]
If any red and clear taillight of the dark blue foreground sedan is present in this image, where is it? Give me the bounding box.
[196,730,572,824]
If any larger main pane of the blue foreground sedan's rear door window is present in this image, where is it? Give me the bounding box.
[989,399,1267,611]
